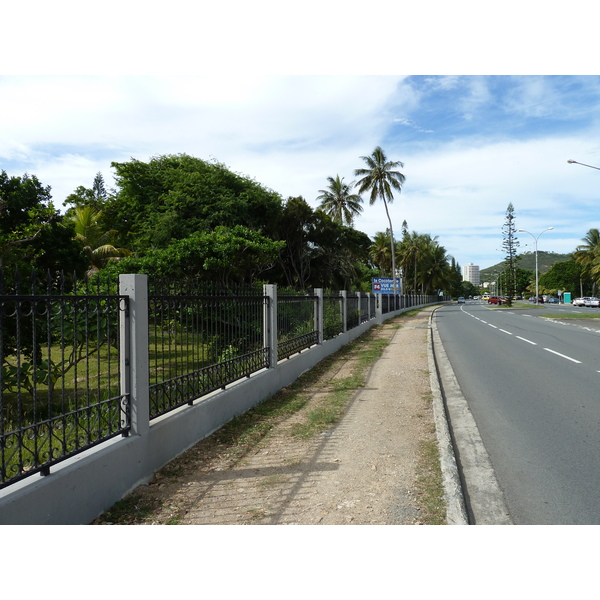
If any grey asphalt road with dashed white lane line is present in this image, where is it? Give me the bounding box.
[435,302,600,524]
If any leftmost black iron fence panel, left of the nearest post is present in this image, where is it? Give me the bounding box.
[0,272,129,488]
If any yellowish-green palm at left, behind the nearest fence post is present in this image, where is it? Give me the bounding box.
[72,206,131,277]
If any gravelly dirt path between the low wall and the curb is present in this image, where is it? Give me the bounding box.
[91,309,443,525]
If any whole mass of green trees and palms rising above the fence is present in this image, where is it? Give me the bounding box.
[0,147,474,293]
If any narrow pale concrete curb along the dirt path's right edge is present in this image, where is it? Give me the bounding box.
[427,309,469,525]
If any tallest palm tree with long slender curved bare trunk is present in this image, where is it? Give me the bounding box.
[354,146,405,295]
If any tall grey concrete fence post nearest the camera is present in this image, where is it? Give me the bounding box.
[119,275,150,435]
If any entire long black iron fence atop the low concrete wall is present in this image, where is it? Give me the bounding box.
[0,272,441,488]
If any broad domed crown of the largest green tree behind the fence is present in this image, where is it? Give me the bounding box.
[104,154,282,252]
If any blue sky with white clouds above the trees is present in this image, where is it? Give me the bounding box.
[0,74,600,268]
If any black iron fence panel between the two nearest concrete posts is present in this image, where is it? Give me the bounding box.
[148,282,268,419]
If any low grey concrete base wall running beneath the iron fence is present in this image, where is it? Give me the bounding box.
[0,307,440,525]
